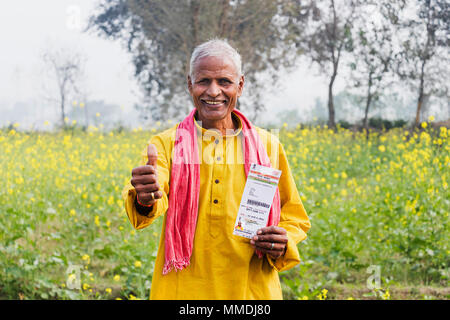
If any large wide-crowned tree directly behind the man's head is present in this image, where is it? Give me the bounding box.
[87,0,295,120]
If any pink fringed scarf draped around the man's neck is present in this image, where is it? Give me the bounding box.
[163,109,281,274]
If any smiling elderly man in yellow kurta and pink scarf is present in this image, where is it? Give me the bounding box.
[123,39,310,299]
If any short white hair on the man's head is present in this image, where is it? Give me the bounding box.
[189,38,242,82]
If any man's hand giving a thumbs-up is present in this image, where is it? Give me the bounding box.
[131,144,162,206]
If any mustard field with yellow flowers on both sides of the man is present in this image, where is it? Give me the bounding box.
[0,121,450,300]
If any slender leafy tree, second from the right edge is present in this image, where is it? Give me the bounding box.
[350,2,394,138]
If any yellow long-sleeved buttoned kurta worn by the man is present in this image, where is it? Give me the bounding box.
[123,113,311,300]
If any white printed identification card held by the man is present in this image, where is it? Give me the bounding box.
[233,163,281,239]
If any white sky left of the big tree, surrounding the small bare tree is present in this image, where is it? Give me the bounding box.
[0,0,137,105]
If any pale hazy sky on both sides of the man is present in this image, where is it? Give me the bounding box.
[0,0,339,127]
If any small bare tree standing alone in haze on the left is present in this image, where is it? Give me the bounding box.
[42,49,83,128]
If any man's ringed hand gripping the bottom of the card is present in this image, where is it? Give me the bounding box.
[250,226,288,259]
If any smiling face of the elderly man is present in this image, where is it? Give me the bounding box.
[188,57,244,122]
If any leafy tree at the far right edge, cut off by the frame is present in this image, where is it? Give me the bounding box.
[384,0,450,126]
